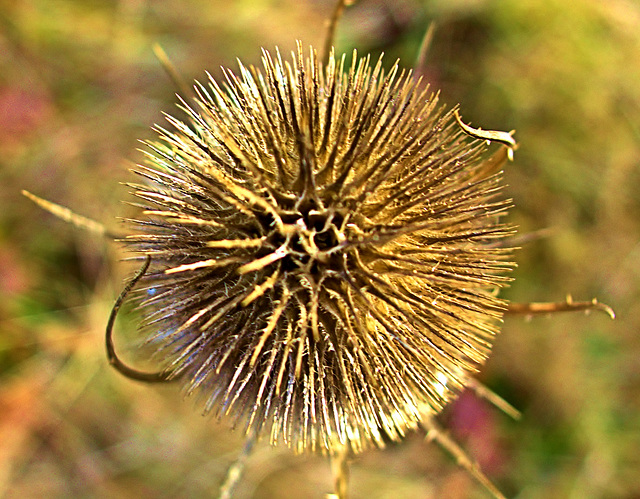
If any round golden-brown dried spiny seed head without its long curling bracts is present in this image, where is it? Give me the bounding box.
[125,46,510,458]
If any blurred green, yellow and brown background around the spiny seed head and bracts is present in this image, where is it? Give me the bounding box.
[0,0,640,499]
